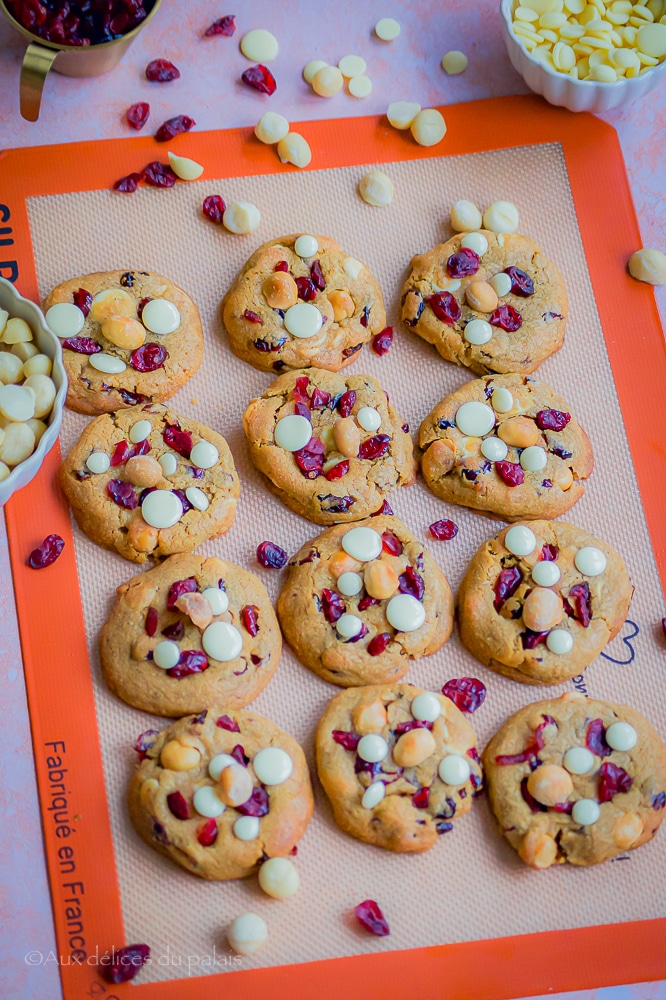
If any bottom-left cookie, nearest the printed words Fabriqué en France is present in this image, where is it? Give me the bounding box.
[128,705,314,881]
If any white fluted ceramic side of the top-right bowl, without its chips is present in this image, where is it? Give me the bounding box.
[500,0,666,114]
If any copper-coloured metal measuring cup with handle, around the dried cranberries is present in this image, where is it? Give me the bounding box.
[0,0,162,122]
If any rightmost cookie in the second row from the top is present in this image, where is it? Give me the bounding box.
[419,375,594,521]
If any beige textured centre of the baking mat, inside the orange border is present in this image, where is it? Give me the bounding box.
[29,145,666,981]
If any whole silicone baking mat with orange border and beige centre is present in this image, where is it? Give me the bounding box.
[0,98,666,1000]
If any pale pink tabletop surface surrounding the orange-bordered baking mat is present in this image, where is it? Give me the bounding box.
[0,0,666,1000]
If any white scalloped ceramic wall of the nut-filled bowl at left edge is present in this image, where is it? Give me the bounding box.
[0,278,67,507]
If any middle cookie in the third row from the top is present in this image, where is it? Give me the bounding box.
[277,515,453,687]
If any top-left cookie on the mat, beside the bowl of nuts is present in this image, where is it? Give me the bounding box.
[42,271,203,415]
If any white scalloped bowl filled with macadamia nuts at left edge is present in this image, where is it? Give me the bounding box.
[0,278,67,506]
